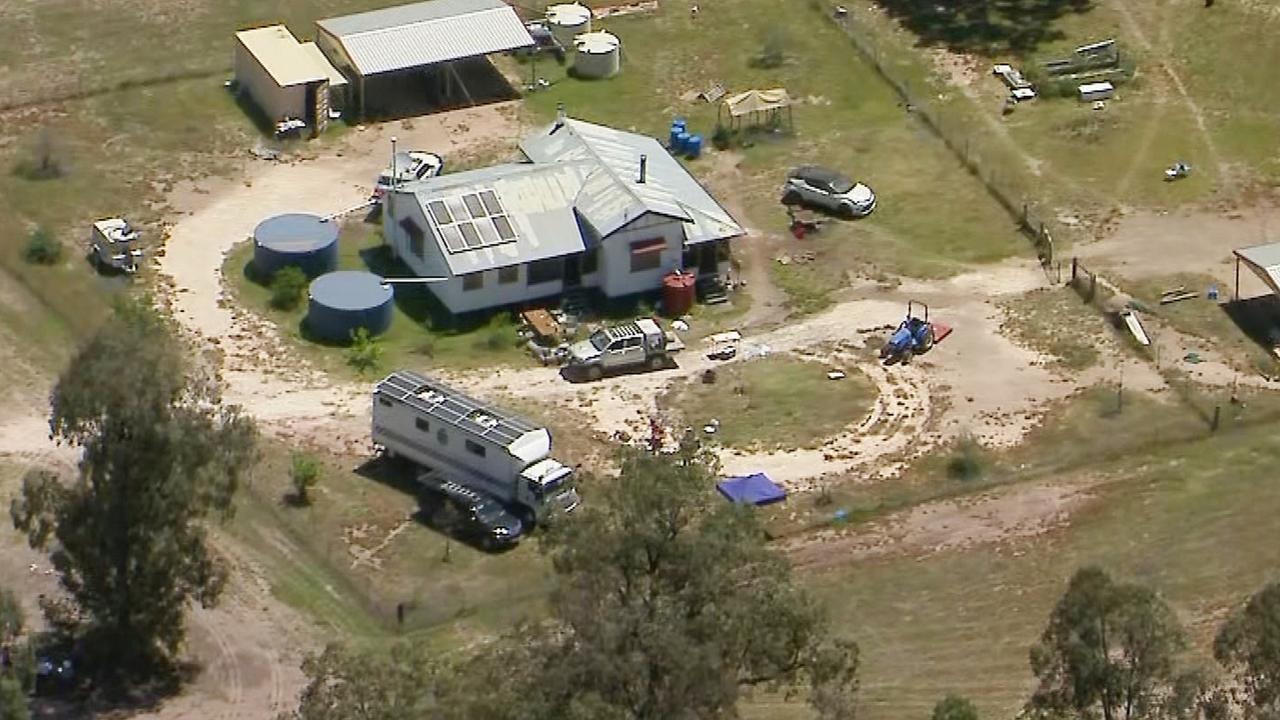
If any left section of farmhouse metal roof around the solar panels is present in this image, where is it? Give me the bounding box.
[401,163,591,275]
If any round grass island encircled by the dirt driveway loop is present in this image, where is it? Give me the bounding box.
[662,356,876,450]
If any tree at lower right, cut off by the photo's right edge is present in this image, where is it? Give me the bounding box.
[1213,583,1280,719]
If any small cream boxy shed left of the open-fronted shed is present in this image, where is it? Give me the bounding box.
[234,26,347,135]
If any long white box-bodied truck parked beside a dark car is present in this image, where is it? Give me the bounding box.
[372,370,579,524]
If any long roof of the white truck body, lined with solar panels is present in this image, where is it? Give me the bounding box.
[376,370,543,447]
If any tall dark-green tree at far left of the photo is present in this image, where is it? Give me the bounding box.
[10,305,256,673]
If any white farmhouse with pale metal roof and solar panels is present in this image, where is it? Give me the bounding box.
[383,117,744,314]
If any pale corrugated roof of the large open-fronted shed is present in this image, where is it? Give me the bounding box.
[316,0,534,76]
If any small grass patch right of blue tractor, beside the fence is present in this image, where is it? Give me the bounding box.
[1001,288,1110,372]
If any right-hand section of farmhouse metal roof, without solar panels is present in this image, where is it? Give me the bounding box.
[520,119,745,245]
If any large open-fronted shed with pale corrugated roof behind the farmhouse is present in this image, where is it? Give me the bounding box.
[316,0,534,115]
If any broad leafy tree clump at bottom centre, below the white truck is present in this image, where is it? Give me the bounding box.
[285,443,858,720]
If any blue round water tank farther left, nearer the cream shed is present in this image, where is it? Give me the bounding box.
[253,213,338,278]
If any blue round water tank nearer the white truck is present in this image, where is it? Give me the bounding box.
[307,270,396,342]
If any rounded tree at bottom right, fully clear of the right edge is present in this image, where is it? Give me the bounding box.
[1029,568,1185,720]
